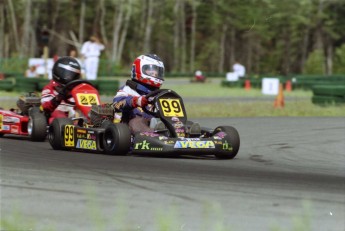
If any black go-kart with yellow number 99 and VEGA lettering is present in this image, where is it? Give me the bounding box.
[48,89,240,159]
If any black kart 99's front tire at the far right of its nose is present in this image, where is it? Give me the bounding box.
[213,126,240,159]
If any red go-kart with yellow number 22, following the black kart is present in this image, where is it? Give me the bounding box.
[0,80,100,141]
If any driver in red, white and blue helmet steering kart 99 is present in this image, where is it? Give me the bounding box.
[113,54,200,134]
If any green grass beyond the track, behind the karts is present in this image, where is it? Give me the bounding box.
[0,81,345,118]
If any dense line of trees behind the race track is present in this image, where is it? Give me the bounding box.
[0,0,345,75]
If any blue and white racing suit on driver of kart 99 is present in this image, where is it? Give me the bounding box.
[113,80,155,133]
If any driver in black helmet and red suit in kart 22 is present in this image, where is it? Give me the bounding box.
[41,56,81,124]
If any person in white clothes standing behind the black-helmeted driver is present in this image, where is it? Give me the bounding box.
[81,35,104,80]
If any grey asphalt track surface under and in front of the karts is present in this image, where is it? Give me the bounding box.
[0,117,345,231]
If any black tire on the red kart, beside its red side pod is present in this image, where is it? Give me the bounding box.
[28,107,48,142]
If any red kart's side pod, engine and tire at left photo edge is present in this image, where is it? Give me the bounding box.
[0,92,47,141]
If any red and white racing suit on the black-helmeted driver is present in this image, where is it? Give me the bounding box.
[41,80,75,124]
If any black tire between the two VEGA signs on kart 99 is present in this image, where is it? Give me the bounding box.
[103,123,131,155]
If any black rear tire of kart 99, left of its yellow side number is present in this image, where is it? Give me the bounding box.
[48,118,73,150]
